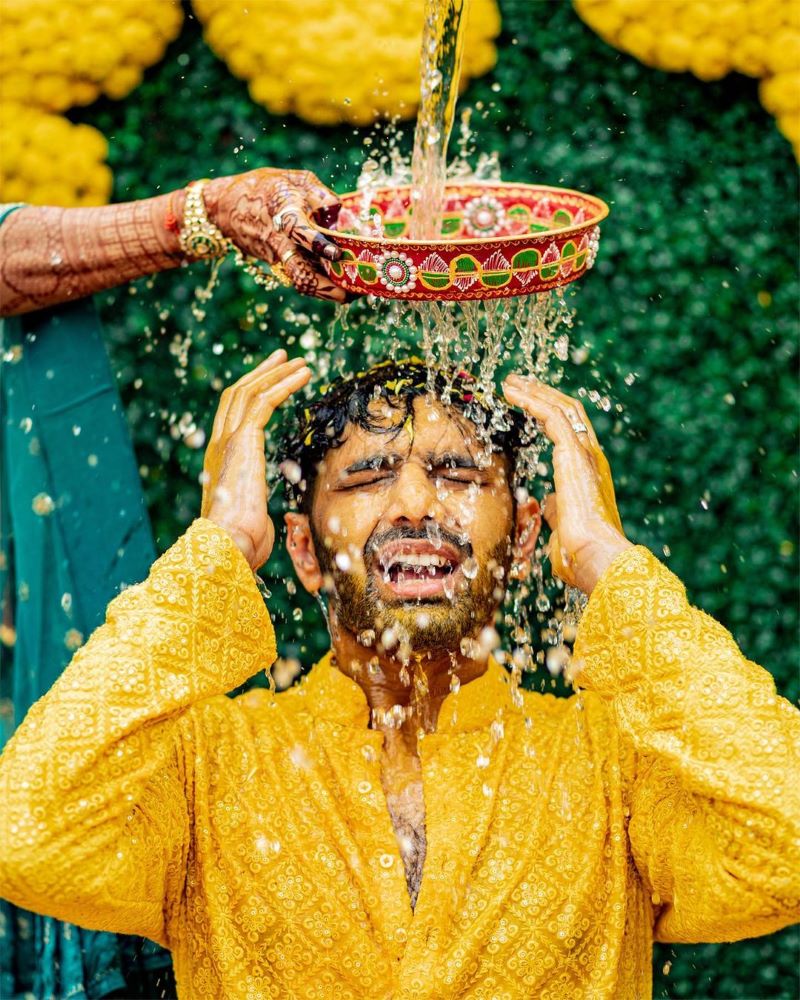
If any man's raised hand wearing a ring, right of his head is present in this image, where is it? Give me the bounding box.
[503,375,631,594]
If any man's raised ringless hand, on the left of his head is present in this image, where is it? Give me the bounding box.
[201,350,311,570]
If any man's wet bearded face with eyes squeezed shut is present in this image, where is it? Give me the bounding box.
[304,397,513,652]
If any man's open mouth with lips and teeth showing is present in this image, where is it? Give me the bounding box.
[378,539,461,600]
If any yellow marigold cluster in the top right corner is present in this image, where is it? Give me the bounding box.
[573,0,800,159]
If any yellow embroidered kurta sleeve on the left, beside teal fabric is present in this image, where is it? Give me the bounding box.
[0,520,275,946]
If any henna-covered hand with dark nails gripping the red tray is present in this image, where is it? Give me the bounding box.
[203,167,348,302]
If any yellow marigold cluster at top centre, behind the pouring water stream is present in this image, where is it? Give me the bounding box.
[192,0,500,125]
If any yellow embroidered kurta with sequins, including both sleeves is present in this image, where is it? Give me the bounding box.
[0,520,800,1000]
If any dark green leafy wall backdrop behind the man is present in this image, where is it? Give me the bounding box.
[73,0,800,1000]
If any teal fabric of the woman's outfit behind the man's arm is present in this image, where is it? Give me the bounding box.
[0,213,175,1000]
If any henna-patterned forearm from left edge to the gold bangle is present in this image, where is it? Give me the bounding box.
[0,190,185,316]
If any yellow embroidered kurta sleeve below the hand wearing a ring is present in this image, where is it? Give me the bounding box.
[575,547,800,942]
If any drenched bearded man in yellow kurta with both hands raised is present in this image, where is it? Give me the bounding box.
[0,352,800,1000]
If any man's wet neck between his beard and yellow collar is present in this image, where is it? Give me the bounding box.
[331,614,487,754]
